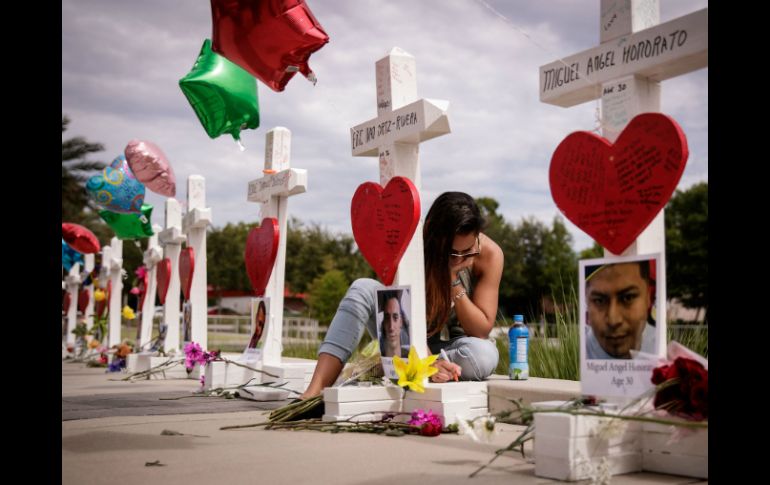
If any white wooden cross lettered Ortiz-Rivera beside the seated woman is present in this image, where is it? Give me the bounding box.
[350,47,450,357]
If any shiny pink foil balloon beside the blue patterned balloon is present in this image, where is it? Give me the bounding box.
[125,140,176,197]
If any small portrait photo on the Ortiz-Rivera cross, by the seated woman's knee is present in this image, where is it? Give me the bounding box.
[376,286,412,379]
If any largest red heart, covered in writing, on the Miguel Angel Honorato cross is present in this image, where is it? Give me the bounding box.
[549,113,689,254]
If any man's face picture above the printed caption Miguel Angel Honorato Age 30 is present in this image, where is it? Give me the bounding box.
[585,260,655,359]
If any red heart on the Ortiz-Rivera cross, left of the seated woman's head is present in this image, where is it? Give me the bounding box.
[350,177,420,285]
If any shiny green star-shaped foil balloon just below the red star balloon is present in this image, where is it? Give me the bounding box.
[179,39,259,141]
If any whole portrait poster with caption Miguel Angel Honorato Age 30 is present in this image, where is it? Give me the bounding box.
[579,253,666,398]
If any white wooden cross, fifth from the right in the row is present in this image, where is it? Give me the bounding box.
[156,198,186,353]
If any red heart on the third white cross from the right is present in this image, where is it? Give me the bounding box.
[243,217,280,296]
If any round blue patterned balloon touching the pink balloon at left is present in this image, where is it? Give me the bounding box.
[86,155,145,214]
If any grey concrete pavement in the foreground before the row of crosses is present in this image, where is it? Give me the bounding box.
[62,363,707,485]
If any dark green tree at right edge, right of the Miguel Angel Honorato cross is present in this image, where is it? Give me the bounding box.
[665,182,708,319]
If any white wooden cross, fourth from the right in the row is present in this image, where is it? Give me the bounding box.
[182,175,211,349]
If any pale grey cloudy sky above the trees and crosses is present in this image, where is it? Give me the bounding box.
[62,0,708,250]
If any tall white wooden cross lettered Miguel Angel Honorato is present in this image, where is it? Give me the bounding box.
[540,0,708,262]
